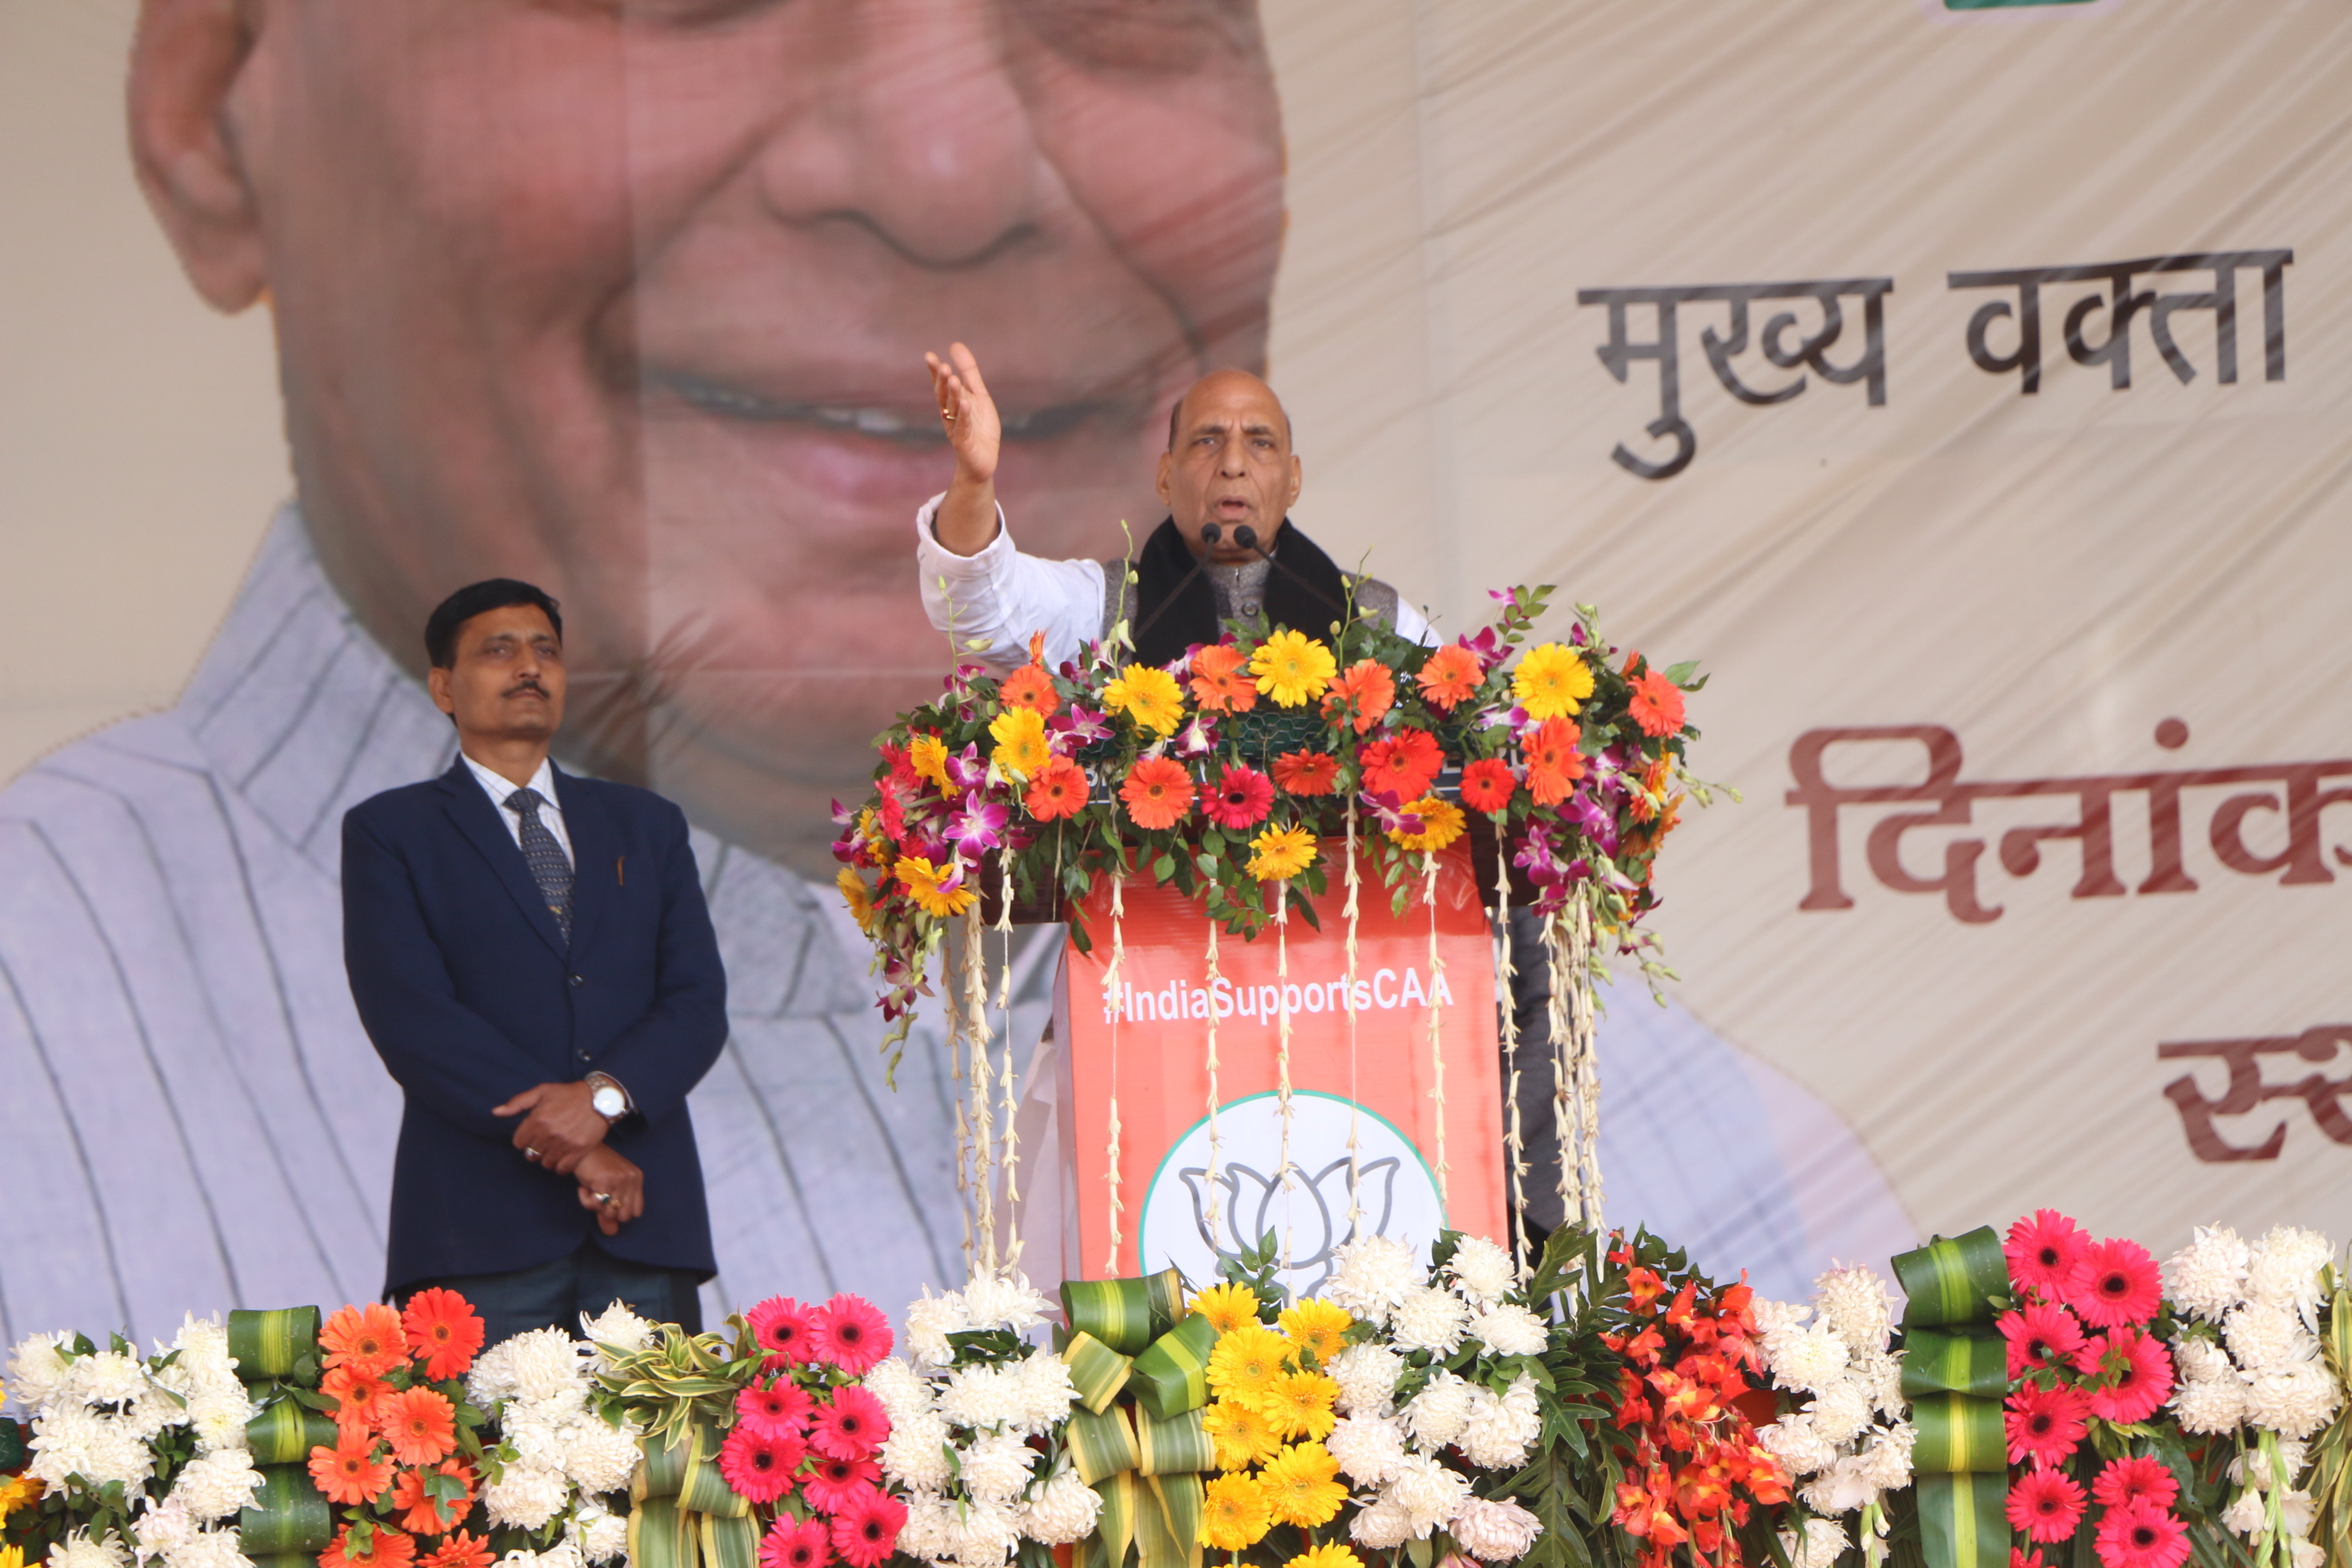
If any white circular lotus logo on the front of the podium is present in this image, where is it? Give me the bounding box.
[1136,1088,1447,1298]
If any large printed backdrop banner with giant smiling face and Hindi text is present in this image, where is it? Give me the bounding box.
[0,0,2352,1338]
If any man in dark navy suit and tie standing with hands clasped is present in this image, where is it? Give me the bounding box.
[343,579,726,1342]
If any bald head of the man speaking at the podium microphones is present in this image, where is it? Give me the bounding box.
[1160,369,1301,562]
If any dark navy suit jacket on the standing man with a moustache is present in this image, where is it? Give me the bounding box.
[343,757,726,1293]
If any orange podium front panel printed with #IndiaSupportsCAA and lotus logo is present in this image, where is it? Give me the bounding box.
[1056,842,1508,1290]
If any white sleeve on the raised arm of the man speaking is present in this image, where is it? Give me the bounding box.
[915,493,1103,670]
